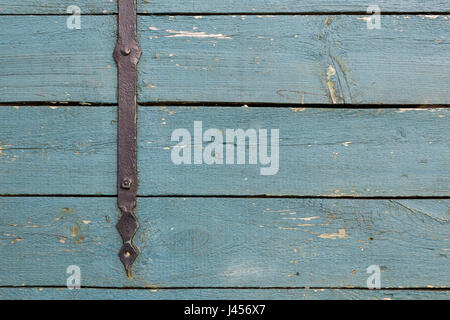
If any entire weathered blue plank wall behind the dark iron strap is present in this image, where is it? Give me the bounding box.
[0,0,450,299]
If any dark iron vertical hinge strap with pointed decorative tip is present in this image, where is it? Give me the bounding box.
[114,0,142,276]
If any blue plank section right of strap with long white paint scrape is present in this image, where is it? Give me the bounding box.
[139,15,450,104]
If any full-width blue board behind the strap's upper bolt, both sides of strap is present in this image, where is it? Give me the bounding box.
[0,15,450,104]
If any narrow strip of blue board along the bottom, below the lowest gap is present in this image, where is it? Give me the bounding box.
[0,288,450,300]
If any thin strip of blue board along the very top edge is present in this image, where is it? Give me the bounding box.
[0,0,450,14]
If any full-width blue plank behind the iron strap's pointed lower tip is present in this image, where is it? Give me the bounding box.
[0,197,450,289]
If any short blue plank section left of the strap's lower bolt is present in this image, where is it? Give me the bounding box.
[0,106,117,194]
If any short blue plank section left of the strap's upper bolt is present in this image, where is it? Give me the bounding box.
[0,15,117,103]
